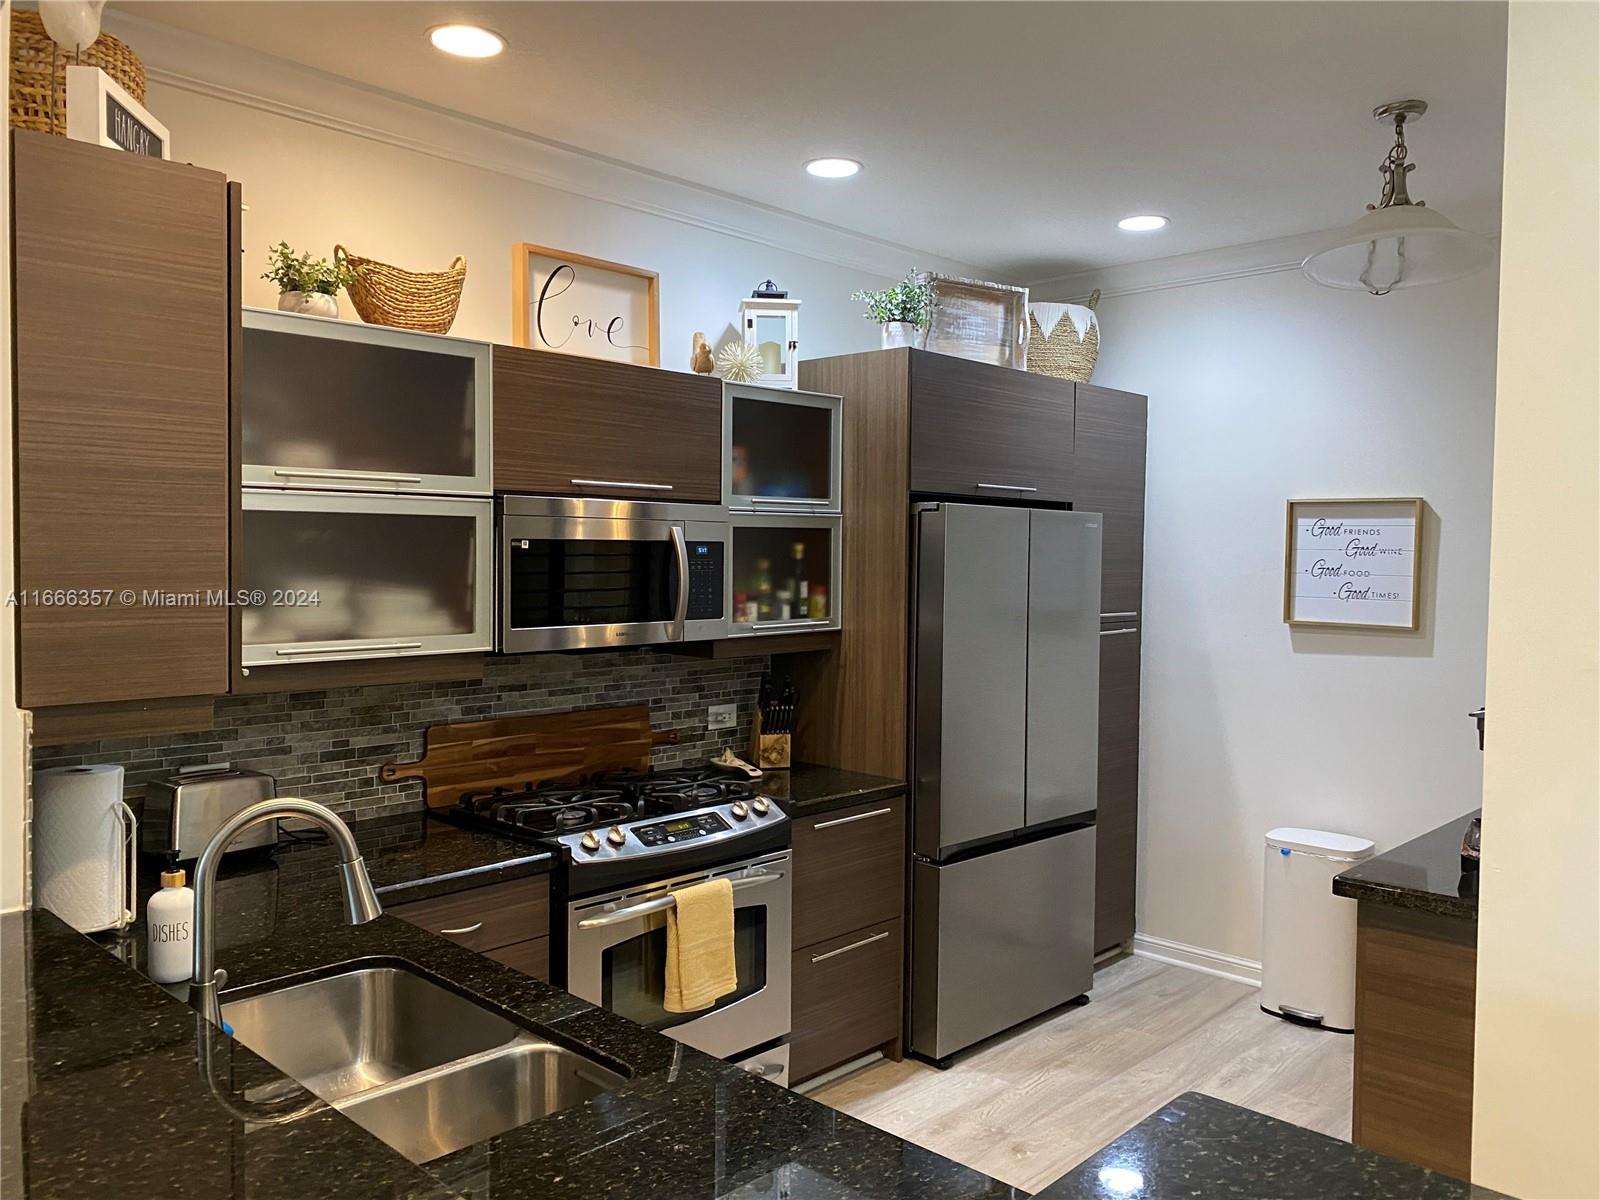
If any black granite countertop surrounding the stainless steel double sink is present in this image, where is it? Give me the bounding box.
[0,821,1024,1200]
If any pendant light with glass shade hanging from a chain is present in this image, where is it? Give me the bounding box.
[1301,99,1494,296]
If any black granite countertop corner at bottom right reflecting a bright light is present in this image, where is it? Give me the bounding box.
[1038,1091,1504,1200]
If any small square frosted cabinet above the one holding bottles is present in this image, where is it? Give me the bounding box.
[722,384,840,514]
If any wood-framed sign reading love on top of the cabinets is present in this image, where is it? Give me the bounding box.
[510,242,661,366]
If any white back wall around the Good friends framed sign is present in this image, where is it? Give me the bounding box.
[1094,270,1496,976]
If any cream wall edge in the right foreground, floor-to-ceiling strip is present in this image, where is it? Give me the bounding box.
[1472,2,1600,1197]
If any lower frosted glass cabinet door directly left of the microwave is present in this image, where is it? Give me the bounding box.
[240,491,494,667]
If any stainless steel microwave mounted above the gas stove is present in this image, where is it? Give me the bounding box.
[499,496,731,654]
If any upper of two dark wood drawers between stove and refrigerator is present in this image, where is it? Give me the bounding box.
[792,797,906,946]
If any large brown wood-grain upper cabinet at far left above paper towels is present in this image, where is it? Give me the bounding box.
[13,131,238,713]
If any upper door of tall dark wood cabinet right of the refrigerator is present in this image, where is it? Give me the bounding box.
[1072,384,1147,616]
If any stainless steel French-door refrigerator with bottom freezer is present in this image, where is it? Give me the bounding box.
[909,502,1101,1061]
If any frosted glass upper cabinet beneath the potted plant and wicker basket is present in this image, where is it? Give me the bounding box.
[242,309,491,496]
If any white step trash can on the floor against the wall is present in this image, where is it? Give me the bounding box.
[1261,829,1373,1034]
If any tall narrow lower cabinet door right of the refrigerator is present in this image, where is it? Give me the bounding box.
[1094,619,1139,954]
